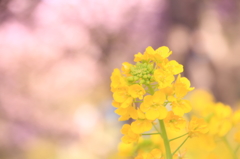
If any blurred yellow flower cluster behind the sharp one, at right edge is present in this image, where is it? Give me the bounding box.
[187,90,240,159]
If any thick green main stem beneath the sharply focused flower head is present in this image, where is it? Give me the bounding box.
[159,120,172,159]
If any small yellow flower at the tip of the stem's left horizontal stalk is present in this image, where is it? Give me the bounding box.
[121,124,140,144]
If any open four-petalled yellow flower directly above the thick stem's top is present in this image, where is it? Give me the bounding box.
[140,91,168,120]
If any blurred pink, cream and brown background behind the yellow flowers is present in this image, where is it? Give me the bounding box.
[0,0,240,159]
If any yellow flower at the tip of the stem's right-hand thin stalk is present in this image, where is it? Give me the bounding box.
[188,116,209,137]
